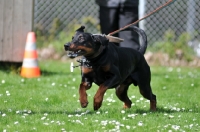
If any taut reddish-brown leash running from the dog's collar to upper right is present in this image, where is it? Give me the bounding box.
[107,0,176,36]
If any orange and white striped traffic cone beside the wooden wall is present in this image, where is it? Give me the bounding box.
[21,32,40,78]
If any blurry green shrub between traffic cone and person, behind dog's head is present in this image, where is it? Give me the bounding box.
[35,16,99,53]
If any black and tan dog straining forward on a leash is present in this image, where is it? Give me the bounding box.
[64,26,156,111]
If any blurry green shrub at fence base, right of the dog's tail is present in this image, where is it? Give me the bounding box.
[150,30,194,61]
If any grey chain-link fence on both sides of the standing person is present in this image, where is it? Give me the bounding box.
[34,0,200,55]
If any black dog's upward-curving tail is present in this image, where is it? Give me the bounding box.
[123,26,147,54]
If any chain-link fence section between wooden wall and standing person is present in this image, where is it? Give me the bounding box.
[34,0,98,33]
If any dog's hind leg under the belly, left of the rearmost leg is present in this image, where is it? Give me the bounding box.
[116,77,132,108]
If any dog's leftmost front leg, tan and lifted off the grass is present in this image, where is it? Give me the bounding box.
[79,82,91,108]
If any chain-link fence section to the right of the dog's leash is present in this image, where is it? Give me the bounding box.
[144,0,200,42]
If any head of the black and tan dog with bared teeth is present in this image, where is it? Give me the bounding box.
[64,26,108,58]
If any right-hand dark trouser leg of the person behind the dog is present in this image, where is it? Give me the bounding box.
[119,6,139,50]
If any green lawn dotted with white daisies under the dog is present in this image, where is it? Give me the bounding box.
[0,61,200,132]
